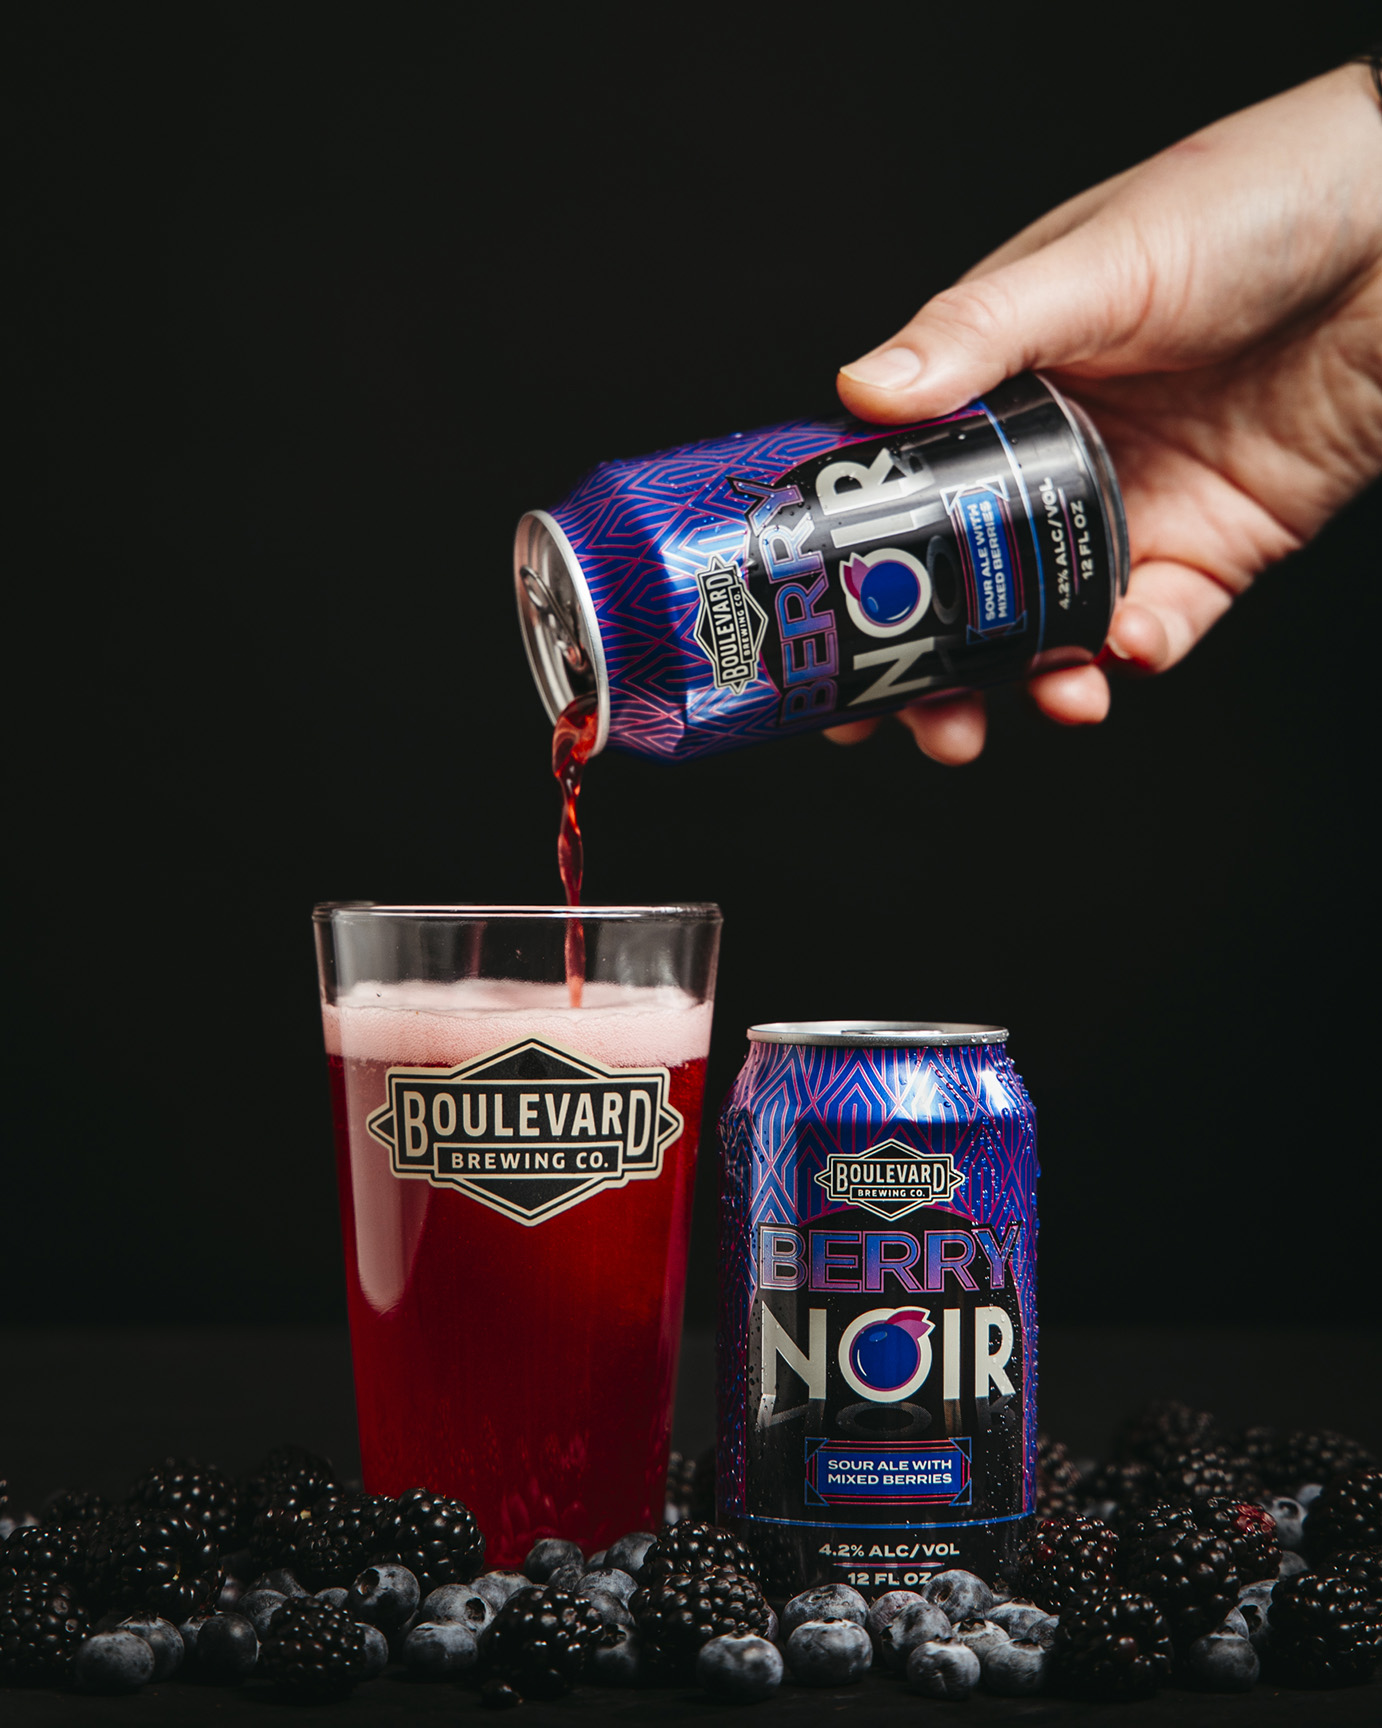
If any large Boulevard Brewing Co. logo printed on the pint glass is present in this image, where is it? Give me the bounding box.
[366,1039,682,1223]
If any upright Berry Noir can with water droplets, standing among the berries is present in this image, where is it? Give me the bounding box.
[717,1021,1037,1598]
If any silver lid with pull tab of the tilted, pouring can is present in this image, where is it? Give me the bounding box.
[513,510,610,755]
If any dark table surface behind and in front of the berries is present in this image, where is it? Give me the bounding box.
[0,1325,1382,1728]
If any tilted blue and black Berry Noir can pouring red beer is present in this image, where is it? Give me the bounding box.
[513,375,1128,759]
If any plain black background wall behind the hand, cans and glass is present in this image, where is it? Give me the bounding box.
[0,3,1382,1325]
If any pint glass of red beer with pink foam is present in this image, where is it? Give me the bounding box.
[314,904,720,1566]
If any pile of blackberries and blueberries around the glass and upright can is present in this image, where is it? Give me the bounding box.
[0,1403,1382,1707]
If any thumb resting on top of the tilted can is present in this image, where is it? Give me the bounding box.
[838,219,1149,422]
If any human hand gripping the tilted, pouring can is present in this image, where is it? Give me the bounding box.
[829,66,1382,762]
